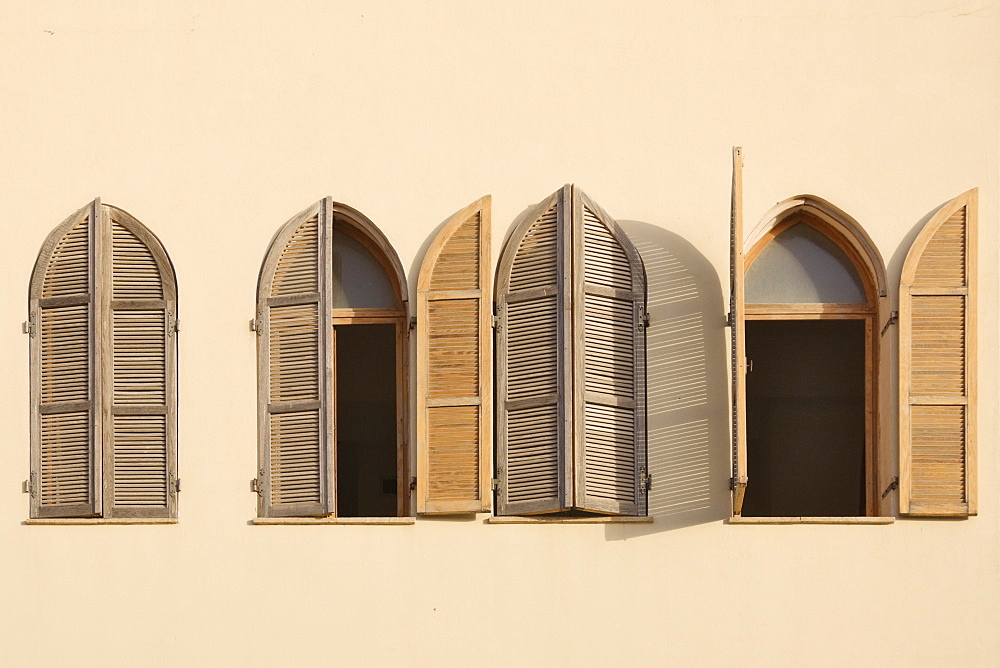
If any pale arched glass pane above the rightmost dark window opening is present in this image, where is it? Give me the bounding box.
[745,223,868,304]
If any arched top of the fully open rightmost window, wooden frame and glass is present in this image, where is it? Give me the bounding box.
[745,195,886,304]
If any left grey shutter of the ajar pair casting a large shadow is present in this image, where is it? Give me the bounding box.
[496,186,572,515]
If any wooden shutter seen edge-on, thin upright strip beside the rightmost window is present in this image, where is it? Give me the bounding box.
[729,146,747,516]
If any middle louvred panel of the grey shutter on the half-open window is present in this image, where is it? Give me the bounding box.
[268,303,320,402]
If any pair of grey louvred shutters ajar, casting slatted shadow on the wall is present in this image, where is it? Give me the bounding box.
[496,185,648,515]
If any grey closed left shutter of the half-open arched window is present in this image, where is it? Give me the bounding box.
[256,198,336,517]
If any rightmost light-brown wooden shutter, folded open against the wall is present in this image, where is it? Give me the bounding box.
[899,189,978,516]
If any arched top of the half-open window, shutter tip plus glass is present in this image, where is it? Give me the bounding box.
[257,197,407,312]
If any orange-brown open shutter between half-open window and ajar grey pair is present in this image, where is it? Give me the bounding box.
[417,195,492,513]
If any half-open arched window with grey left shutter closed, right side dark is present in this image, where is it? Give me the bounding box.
[255,198,409,517]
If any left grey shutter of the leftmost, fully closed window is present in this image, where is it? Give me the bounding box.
[28,200,102,518]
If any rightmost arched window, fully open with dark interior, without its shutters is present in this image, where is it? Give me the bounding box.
[734,196,886,517]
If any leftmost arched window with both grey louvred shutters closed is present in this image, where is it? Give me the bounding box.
[27,200,177,518]
